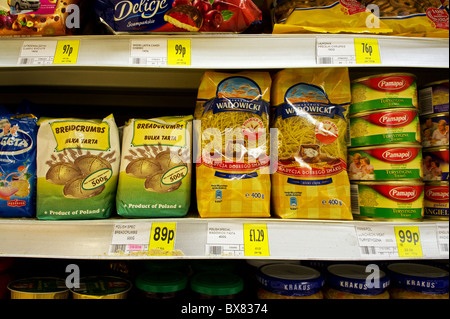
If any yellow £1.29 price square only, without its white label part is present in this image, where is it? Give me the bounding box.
[244,224,270,257]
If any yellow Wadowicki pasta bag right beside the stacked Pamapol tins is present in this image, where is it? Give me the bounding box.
[272,68,352,219]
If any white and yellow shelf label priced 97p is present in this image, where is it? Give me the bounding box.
[17,40,80,65]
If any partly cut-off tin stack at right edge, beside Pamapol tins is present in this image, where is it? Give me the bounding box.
[419,80,449,220]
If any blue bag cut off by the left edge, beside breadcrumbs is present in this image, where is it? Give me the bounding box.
[0,114,38,217]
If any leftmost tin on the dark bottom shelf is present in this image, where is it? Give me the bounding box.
[8,277,69,299]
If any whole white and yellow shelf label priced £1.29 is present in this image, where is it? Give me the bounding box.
[205,222,270,257]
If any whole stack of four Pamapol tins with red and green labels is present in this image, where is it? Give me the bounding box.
[348,73,424,220]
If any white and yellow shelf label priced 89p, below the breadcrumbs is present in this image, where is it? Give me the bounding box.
[108,222,177,255]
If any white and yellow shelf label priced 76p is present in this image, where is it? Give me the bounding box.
[316,38,381,65]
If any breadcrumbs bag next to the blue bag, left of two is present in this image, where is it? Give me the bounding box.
[36,114,120,219]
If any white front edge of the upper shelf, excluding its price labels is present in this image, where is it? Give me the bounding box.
[0,34,449,69]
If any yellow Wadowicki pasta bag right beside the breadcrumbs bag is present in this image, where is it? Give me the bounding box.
[195,72,271,217]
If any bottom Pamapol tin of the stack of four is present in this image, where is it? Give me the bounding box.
[350,180,424,221]
